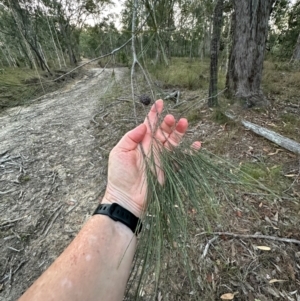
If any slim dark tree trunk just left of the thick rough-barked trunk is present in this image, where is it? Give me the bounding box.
[208,0,224,107]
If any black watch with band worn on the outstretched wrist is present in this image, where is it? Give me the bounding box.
[93,203,142,234]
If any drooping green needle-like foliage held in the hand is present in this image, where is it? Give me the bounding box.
[127,124,279,300]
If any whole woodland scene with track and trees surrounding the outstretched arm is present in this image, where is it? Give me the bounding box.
[0,0,300,301]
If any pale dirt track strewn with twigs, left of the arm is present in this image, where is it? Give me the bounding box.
[0,69,134,301]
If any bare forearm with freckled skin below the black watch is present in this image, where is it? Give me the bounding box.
[19,215,136,301]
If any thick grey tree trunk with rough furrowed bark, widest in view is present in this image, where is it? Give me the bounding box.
[226,0,274,107]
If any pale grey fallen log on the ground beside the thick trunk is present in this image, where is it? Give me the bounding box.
[225,113,300,155]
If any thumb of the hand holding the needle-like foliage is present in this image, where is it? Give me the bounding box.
[116,124,147,151]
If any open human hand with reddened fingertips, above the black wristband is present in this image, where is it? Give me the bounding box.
[102,100,201,217]
